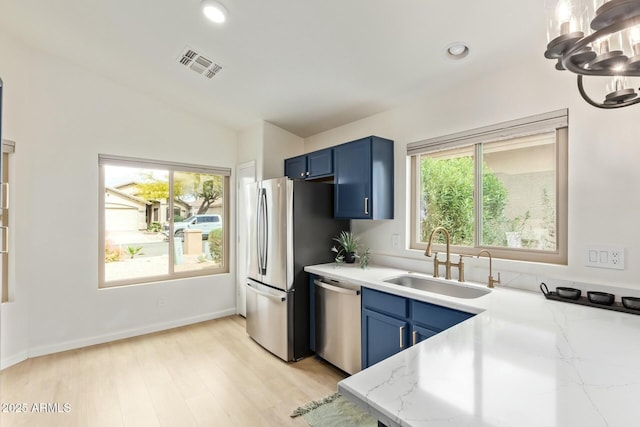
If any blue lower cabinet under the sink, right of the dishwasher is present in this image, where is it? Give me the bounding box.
[362,288,473,369]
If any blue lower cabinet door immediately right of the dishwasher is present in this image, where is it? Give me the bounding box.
[362,309,410,369]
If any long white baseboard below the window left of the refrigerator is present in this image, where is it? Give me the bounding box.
[22,308,236,362]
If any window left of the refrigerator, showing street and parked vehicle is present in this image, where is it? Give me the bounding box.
[99,155,231,287]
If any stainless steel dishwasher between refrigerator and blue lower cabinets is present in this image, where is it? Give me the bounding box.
[313,278,362,374]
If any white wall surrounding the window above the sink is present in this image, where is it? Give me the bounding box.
[305,52,640,289]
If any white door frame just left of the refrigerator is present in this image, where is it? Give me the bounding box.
[236,160,256,317]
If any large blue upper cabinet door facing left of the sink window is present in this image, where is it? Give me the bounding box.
[334,138,373,219]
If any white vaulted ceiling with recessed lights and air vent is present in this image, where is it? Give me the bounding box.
[0,0,546,137]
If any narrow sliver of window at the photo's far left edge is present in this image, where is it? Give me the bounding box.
[0,139,15,302]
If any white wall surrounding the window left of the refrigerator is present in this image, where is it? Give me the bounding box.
[0,33,237,366]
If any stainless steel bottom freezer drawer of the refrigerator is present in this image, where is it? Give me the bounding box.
[246,279,292,361]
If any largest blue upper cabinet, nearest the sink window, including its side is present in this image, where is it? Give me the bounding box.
[334,136,393,219]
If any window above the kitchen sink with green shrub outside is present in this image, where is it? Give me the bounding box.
[407,110,567,264]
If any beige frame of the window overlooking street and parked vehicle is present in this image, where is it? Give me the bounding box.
[98,154,231,289]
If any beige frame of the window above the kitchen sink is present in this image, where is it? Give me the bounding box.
[407,109,568,265]
